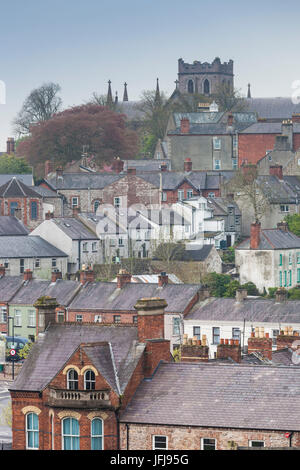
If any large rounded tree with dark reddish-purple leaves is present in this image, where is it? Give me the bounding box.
[17,104,138,173]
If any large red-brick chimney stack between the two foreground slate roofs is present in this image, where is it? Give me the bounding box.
[134,297,171,377]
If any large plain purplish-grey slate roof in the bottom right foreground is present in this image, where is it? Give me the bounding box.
[120,363,300,431]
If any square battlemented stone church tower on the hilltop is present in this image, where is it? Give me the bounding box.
[178,57,234,96]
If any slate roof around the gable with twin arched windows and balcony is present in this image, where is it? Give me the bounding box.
[10,323,145,393]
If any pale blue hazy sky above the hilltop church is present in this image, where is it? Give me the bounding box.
[0,0,300,151]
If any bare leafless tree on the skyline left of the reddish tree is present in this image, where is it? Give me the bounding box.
[13,82,62,136]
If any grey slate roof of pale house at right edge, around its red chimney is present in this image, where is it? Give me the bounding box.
[236,228,300,250]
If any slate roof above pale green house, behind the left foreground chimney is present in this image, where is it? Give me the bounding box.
[7,277,81,306]
